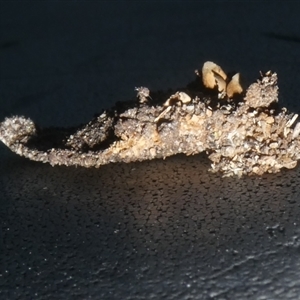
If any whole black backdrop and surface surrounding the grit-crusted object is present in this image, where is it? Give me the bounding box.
[0,1,300,299]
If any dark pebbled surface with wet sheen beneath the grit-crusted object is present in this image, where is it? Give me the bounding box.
[0,155,300,299]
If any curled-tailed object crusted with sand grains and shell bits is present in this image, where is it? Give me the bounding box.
[0,62,300,177]
